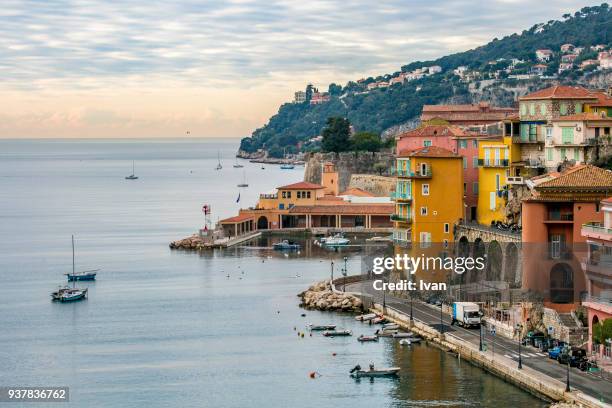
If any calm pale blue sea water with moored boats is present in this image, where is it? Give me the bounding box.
[0,140,542,407]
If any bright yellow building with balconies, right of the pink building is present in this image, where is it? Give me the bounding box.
[476,136,521,225]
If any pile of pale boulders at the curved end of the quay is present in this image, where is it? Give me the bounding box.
[298,280,363,312]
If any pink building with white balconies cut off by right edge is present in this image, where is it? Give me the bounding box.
[582,197,612,358]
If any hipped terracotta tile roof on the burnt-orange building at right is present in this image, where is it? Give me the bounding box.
[536,164,612,191]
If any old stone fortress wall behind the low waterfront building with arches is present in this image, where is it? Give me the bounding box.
[304,150,395,191]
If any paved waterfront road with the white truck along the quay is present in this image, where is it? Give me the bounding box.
[340,281,612,404]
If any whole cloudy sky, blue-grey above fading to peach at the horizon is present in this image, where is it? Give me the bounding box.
[0,0,601,138]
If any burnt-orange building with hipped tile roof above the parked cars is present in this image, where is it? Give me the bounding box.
[522,165,612,313]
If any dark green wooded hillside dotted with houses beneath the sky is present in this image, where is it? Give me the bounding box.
[240,4,612,157]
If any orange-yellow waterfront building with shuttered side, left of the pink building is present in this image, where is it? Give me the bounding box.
[392,146,463,244]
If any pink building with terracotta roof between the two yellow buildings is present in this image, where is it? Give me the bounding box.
[397,125,486,221]
